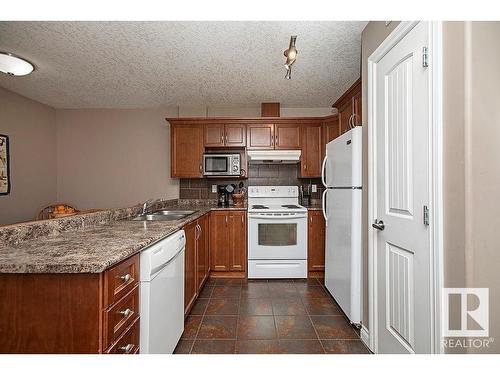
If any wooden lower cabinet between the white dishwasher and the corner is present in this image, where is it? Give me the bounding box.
[184,214,210,315]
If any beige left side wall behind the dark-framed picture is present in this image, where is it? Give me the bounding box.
[0,88,56,225]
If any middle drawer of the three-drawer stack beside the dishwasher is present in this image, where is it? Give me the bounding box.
[103,285,139,348]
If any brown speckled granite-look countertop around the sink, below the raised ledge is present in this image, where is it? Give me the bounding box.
[0,204,246,273]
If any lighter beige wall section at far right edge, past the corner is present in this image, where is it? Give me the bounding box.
[460,22,500,353]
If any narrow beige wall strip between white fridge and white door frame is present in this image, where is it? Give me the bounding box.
[361,21,399,328]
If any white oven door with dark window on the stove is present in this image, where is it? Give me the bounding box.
[248,213,307,259]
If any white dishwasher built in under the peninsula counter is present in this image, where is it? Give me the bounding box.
[139,230,186,354]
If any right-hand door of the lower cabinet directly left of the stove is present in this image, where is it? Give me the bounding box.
[229,211,247,271]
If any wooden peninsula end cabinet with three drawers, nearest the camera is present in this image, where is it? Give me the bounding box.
[0,254,139,354]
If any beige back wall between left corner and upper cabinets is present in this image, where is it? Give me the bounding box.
[56,109,179,209]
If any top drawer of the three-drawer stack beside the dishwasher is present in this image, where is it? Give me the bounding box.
[104,254,139,307]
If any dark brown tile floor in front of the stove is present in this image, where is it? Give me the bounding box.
[175,279,369,354]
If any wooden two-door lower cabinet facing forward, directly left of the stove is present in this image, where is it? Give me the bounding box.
[210,210,247,272]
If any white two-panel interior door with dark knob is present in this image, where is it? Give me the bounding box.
[372,22,432,353]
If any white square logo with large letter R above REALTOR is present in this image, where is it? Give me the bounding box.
[443,288,489,337]
